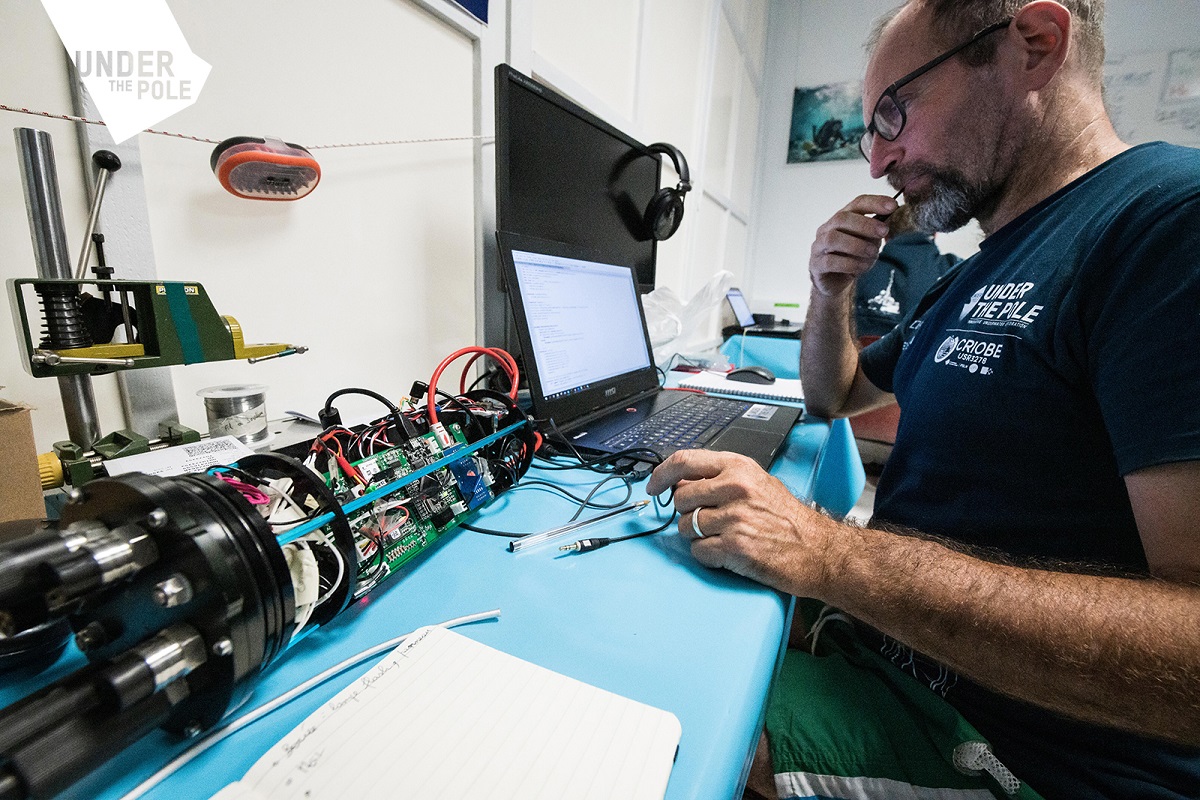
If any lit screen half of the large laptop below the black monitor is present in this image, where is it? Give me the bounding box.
[497,233,658,425]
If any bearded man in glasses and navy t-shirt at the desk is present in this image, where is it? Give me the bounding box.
[647,0,1200,798]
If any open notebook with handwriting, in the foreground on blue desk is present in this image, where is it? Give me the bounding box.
[214,627,682,800]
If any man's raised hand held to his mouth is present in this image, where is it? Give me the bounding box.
[809,194,899,297]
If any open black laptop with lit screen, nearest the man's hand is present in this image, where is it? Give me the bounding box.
[497,231,800,469]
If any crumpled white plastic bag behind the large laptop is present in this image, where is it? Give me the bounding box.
[642,270,733,366]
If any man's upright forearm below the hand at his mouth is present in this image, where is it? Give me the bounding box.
[800,285,858,416]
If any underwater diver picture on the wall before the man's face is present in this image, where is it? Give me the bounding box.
[787,80,865,164]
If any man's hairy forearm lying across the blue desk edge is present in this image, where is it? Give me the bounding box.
[816,521,1200,746]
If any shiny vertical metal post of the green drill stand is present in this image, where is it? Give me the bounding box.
[14,128,100,449]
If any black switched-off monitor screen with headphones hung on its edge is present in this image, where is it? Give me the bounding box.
[496,64,661,290]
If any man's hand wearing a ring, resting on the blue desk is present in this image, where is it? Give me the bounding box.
[646,450,834,596]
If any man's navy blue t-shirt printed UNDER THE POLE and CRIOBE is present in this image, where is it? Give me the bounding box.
[862,143,1200,798]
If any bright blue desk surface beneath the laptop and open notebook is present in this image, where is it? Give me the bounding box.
[0,359,862,800]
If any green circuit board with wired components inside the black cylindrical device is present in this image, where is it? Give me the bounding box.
[325,423,493,596]
